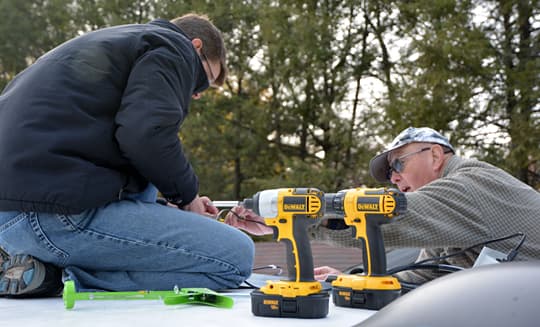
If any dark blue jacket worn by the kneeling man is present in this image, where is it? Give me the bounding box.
[0,20,208,213]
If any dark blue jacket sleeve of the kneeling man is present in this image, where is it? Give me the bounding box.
[115,47,198,204]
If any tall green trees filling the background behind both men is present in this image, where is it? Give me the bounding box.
[0,0,540,195]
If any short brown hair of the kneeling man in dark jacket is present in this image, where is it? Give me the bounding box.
[171,13,228,85]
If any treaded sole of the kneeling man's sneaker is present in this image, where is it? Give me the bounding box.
[0,254,46,297]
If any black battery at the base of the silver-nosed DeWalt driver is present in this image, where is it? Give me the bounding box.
[251,290,330,318]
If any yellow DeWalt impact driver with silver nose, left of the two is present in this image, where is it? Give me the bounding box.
[241,188,330,318]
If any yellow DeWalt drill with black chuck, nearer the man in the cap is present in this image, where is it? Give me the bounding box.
[325,188,407,310]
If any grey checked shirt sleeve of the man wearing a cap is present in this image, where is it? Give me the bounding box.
[381,176,493,247]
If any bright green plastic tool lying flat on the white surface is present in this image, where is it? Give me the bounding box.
[62,280,234,309]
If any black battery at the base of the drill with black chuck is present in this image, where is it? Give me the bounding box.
[332,286,401,310]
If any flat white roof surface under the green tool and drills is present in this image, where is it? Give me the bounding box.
[0,289,376,327]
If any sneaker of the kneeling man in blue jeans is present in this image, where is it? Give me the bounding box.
[0,254,63,298]
